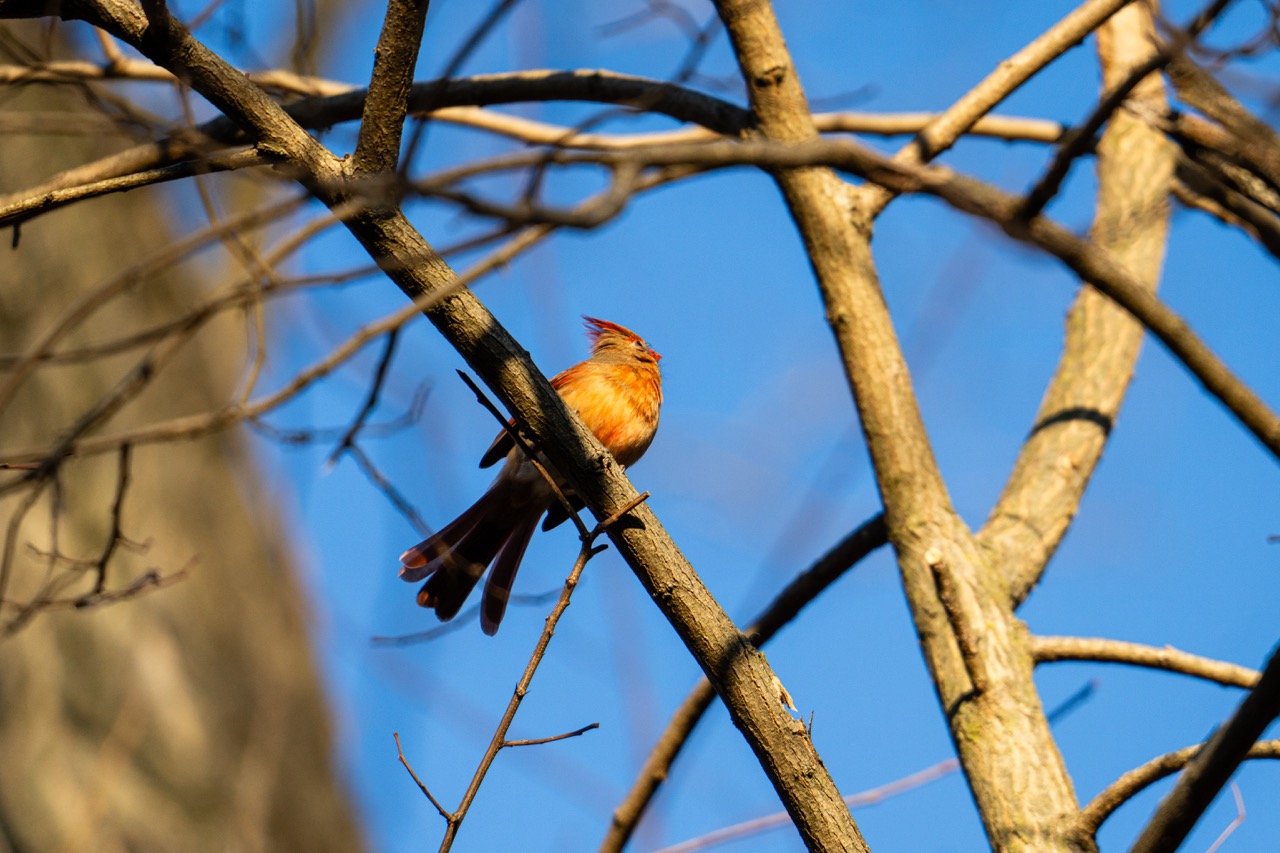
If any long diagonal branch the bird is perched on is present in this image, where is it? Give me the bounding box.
[57,0,865,849]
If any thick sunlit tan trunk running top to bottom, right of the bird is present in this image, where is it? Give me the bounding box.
[718,0,1093,850]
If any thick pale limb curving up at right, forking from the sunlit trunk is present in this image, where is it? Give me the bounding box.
[978,3,1174,606]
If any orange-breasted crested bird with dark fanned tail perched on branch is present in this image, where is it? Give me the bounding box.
[399,315,662,637]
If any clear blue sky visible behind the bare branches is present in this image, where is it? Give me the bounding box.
[199,0,1280,853]
